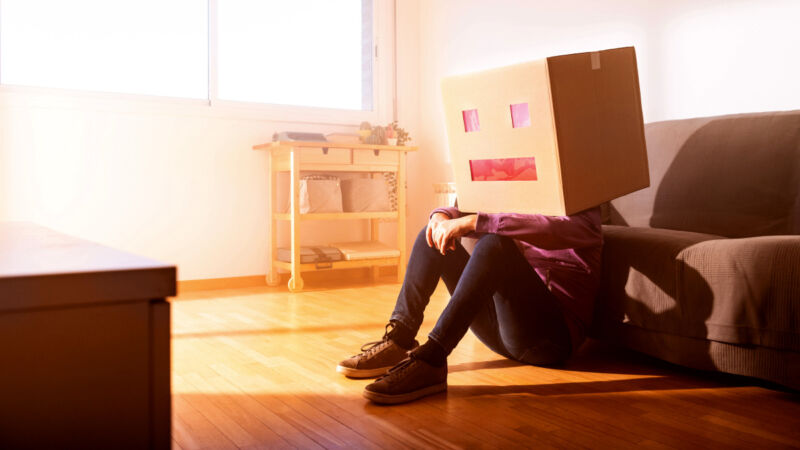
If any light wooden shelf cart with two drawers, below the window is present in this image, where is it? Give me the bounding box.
[253,141,417,292]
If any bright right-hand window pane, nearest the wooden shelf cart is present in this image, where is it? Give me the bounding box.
[217,0,374,111]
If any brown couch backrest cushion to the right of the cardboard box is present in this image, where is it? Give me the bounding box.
[609,111,800,237]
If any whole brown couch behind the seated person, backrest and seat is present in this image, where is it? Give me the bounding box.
[593,111,800,389]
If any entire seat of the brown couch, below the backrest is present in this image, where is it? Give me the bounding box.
[595,226,800,350]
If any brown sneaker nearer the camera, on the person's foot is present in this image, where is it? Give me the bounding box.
[364,352,447,405]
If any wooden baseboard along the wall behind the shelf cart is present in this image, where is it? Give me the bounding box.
[178,266,397,293]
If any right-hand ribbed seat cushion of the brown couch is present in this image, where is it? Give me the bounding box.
[677,236,800,351]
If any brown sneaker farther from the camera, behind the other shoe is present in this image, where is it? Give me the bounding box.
[336,323,419,378]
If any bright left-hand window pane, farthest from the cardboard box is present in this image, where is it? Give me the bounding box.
[0,0,208,99]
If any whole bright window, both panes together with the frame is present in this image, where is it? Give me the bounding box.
[0,0,384,123]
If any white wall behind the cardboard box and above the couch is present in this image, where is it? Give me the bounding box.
[409,0,800,239]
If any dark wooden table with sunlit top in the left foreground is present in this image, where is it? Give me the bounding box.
[0,222,176,449]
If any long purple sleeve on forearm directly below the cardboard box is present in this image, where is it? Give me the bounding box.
[475,207,603,250]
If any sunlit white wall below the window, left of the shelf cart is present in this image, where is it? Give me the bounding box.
[0,95,372,280]
